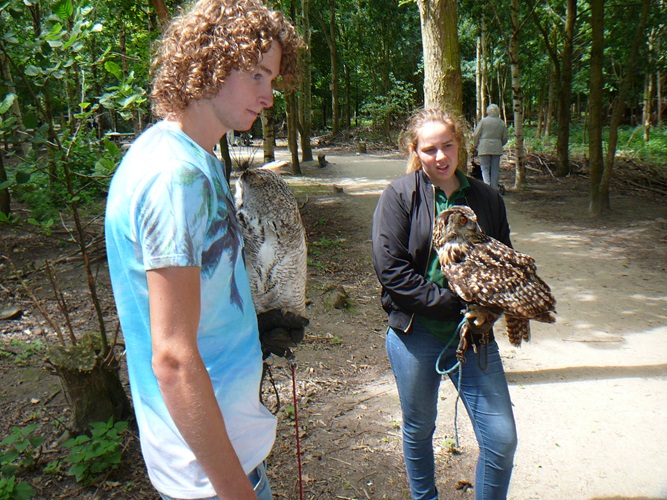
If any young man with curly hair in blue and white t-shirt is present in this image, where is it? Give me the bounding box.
[105,0,302,500]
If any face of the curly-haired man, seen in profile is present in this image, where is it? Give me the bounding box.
[213,43,282,130]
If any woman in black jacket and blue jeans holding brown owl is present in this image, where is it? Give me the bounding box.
[372,109,517,500]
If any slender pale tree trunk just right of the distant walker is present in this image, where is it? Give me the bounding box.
[510,0,526,189]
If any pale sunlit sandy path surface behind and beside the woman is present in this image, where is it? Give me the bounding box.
[290,155,667,499]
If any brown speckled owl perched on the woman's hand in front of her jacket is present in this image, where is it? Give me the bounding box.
[433,206,556,346]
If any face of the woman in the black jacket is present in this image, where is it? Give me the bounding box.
[416,122,459,191]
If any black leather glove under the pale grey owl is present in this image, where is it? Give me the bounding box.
[257,309,310,359]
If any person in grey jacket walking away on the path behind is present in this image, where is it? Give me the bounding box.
[472,104,507,189]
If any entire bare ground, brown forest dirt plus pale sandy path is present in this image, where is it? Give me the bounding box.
[0,150,667,500]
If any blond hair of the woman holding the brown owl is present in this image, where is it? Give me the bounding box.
[400,108,469,174]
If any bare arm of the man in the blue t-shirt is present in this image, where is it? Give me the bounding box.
[146,267,256,500]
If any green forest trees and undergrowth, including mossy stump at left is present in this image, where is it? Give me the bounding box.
[0,0,667,498]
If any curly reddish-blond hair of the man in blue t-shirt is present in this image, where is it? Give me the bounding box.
[151,0,303,117]
